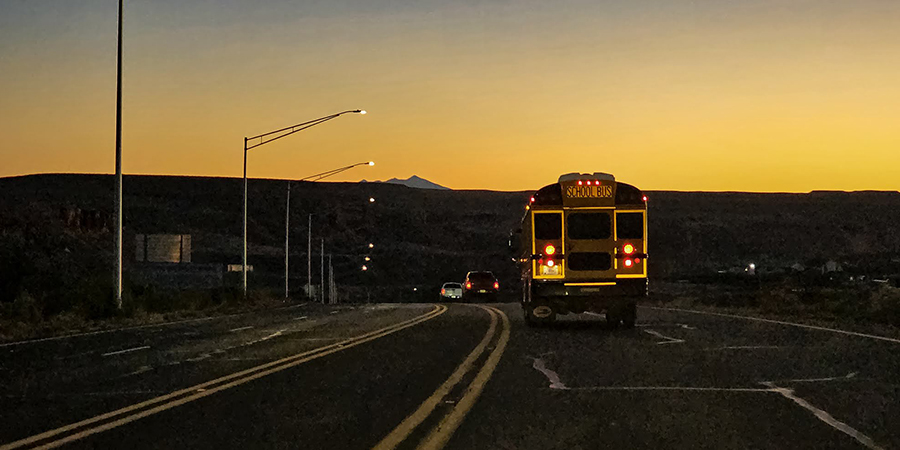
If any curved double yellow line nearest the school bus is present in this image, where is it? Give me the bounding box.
[374,305,510,450]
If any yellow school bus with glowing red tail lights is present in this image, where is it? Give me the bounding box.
[510,172,647,327]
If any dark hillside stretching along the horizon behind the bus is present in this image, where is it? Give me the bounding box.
[0,175,900,301]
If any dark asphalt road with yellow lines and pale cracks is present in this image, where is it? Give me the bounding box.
[0,304,900,449]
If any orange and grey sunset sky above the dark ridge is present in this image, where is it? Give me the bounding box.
[0,0,900,192]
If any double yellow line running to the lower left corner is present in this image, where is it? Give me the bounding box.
[0,305,447,450]
